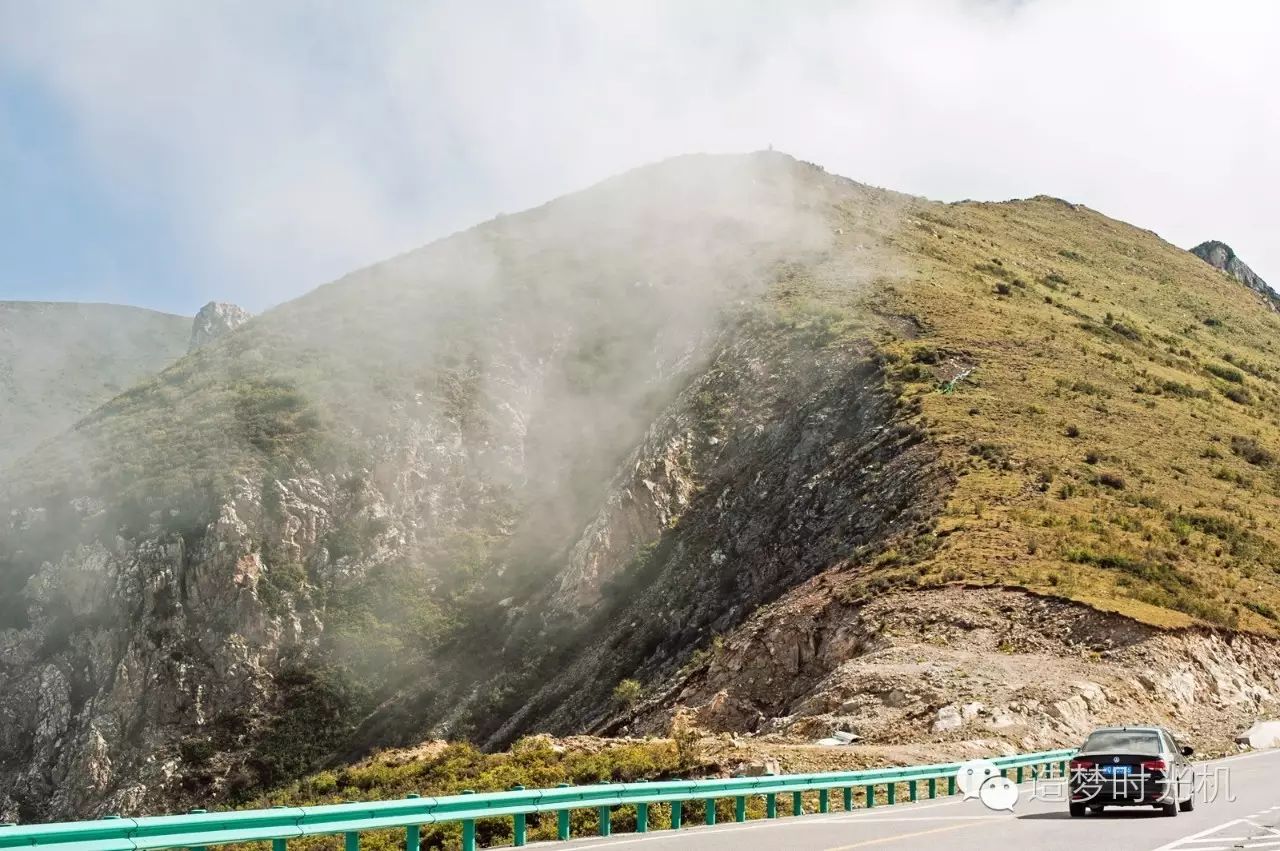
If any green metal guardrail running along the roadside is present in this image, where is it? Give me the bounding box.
[0,750,1075,851]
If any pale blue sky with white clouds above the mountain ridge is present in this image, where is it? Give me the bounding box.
[0,0,1280,314]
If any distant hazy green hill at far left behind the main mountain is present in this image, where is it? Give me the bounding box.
[0,302,191,468]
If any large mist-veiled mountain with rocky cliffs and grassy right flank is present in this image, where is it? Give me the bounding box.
[0,152,1280,820]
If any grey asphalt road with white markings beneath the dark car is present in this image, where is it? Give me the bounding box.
[544,750,1280,851]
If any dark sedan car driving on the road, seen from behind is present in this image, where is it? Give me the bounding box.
[1070,727,1196,815]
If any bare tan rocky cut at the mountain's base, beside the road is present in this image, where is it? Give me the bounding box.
[602,588,1280,750]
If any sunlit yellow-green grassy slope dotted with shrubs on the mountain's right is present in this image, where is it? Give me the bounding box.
[865,191,1280,632]
